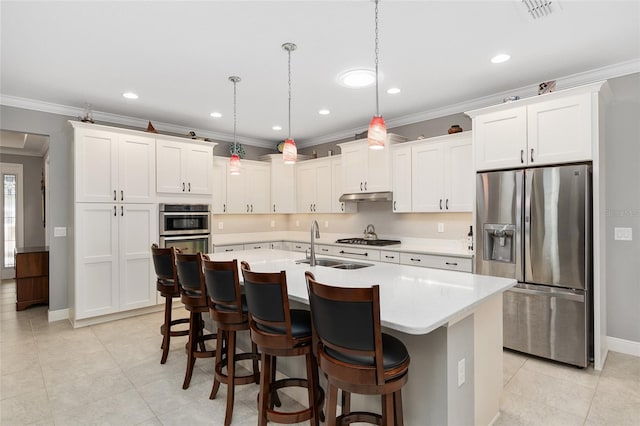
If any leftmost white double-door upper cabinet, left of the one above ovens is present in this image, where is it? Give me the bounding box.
[73,123,156,203]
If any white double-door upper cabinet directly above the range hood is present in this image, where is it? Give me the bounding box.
[338,134,406,194]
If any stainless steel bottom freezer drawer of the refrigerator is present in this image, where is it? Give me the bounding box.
[503,284,589,367]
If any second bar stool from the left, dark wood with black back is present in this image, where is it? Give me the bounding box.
[176,253,217,389]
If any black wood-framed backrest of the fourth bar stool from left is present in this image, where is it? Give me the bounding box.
[241,261,295,348]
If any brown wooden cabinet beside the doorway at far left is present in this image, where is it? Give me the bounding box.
[14,247,49,311]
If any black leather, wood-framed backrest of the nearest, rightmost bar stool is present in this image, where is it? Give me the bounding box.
[305,271,384,384]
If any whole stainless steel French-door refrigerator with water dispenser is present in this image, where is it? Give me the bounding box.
[475,164,593,367]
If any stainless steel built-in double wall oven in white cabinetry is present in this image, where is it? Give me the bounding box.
[159,204,212,253]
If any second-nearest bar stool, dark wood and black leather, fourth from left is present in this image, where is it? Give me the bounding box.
[241,262,324,426]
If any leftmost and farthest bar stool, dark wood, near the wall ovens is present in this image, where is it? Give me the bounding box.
[151,244,189,364]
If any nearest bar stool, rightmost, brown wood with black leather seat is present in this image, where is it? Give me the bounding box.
[305,271,410,426]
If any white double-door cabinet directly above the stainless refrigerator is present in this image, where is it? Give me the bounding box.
[467,83,602,170]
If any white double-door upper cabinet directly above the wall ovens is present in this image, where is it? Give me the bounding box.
[156,139,213,195]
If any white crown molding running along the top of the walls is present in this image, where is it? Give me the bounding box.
[0,58,640,148]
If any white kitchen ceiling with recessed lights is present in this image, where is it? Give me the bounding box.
[0,0,640,146]
